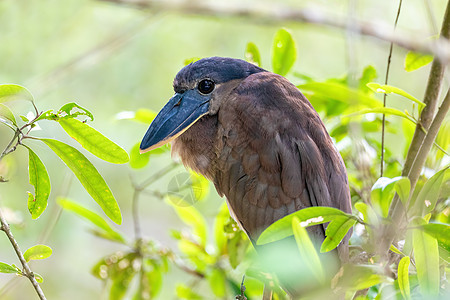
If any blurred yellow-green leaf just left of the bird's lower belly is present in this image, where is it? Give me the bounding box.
[167,195,208,246]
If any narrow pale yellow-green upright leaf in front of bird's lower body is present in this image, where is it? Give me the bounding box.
[292,217,325,282]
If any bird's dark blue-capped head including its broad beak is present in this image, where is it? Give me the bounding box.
[140,57,265,153]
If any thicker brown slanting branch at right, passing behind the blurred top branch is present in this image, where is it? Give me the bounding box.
[402,1,450,176]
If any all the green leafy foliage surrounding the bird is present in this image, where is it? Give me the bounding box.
[0,14,450,299]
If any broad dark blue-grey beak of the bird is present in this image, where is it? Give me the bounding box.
[139,90,210,153]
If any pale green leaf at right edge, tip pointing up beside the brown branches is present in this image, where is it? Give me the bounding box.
[414,167,449,215]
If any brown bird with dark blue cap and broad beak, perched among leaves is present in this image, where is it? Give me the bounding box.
[140,57,351,298]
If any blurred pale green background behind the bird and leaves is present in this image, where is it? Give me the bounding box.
[0,0,445,300]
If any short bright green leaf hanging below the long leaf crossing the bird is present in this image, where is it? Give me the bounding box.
[320,216,356,253]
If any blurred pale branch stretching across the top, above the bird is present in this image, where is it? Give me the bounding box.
[98,0,450,64]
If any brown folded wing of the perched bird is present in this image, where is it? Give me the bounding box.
[214,72,350,246]
